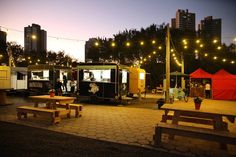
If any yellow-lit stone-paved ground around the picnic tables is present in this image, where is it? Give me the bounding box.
[0,95,236,156]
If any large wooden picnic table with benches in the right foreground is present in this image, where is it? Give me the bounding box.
[154,103,236,149]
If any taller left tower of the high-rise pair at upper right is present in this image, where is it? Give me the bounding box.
[171,9,195,31]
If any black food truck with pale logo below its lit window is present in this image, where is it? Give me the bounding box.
[77,63,129,100]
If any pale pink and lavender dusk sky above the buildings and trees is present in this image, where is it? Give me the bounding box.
[0,0,236,61]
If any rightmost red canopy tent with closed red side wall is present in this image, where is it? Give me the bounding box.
[212,69,236,100]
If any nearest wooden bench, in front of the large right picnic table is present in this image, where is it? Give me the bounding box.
[153,123,236,149]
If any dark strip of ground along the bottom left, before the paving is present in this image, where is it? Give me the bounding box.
[0,121,183,157]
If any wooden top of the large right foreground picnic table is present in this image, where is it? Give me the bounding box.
[161,102,236,117]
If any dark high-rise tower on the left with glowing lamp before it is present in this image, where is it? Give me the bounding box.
[24,24,47,53]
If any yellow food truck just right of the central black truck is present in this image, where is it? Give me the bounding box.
[129,67,146,96]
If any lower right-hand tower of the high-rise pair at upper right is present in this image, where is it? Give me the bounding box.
[198,16,221,43]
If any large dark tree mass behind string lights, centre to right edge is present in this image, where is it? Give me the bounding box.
[87,24,236,86]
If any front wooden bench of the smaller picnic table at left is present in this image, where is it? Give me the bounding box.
[16,106,61,124]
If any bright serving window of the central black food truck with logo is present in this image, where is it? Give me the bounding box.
[83,69,111,82]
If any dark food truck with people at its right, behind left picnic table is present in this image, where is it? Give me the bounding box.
[28,64,71,95]
